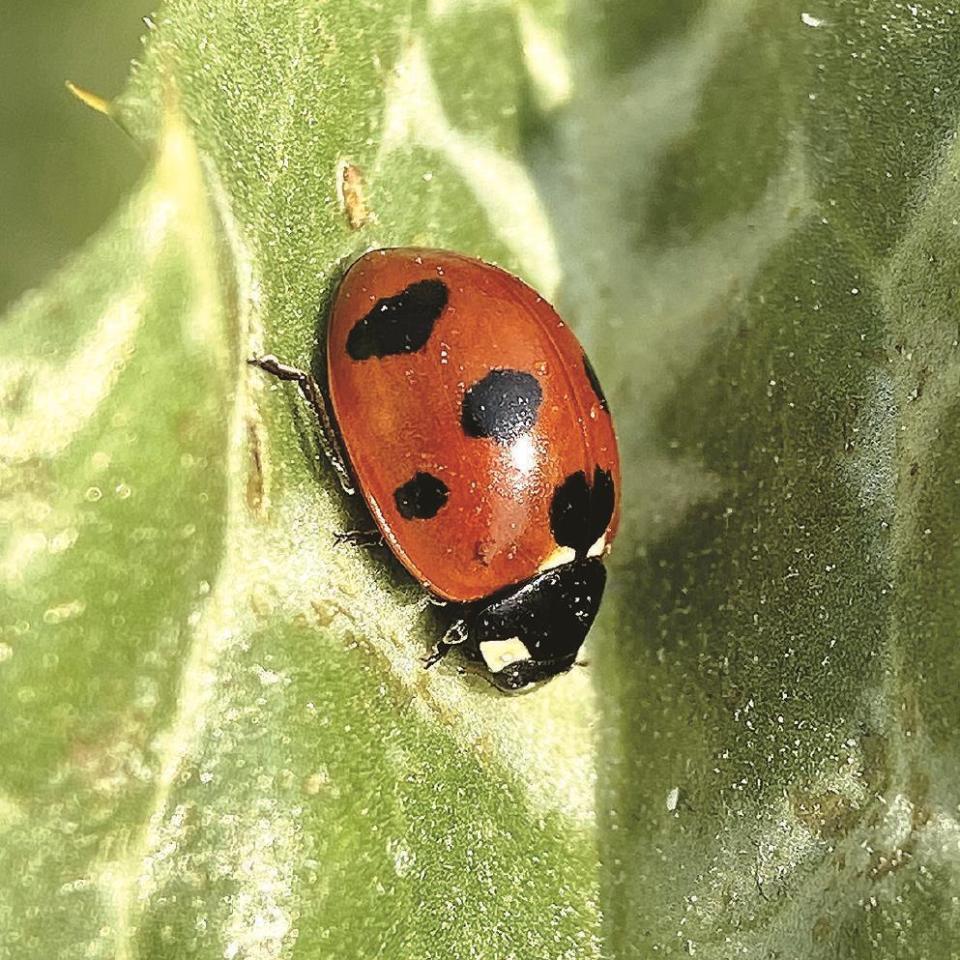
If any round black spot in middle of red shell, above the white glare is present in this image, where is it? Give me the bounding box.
[460,370,543,443]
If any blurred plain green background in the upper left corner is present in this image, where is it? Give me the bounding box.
[0,0,149,306]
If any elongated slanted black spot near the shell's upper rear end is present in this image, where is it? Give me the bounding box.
[347,280,449,360]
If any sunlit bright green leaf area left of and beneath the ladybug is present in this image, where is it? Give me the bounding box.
[0,3,599,958]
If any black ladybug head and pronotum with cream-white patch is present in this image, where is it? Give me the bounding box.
[464,559,607,693]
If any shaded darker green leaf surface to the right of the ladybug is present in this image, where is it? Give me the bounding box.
[539,0,960,960]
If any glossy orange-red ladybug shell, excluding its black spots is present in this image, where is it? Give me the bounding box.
[327,248,620,601]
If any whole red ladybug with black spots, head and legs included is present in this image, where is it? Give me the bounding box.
[251,248,620,692]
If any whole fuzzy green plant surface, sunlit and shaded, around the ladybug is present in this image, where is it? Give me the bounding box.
[0,0,960,960]
